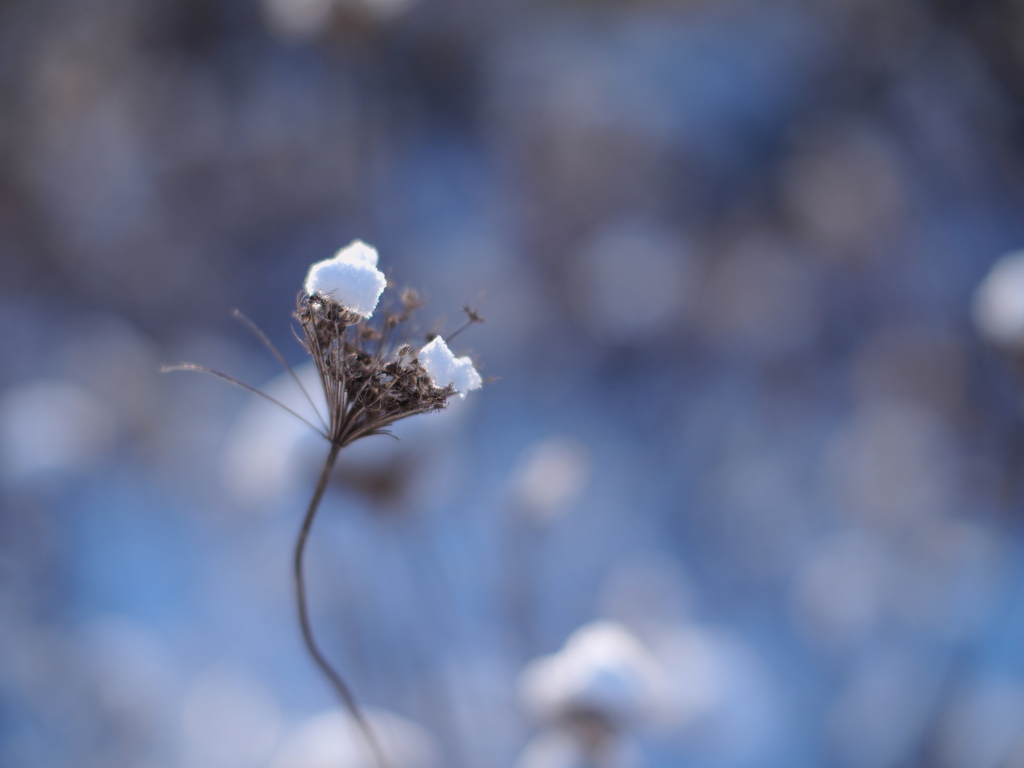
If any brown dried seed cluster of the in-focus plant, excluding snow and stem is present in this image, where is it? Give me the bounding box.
[295,291,455,445]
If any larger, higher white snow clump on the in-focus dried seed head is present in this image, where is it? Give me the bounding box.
[303,240,387,317]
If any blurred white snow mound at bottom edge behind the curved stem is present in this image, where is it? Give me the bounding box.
[270,711,440,768]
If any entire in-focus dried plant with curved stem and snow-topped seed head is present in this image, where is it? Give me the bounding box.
[164,241,482,768]
